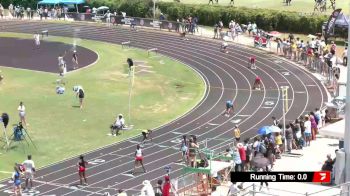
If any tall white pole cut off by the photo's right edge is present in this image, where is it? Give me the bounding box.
[343,10,350,196]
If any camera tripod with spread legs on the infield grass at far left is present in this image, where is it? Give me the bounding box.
[6,125,37,151]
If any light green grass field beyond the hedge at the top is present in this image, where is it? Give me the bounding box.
[160,0,349,13]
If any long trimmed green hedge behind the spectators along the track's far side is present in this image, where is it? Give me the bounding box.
[90,0,328,34]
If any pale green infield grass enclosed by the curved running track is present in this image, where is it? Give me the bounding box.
[0,34,205,178]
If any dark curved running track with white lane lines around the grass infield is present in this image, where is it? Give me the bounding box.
[0,21,327,196]
